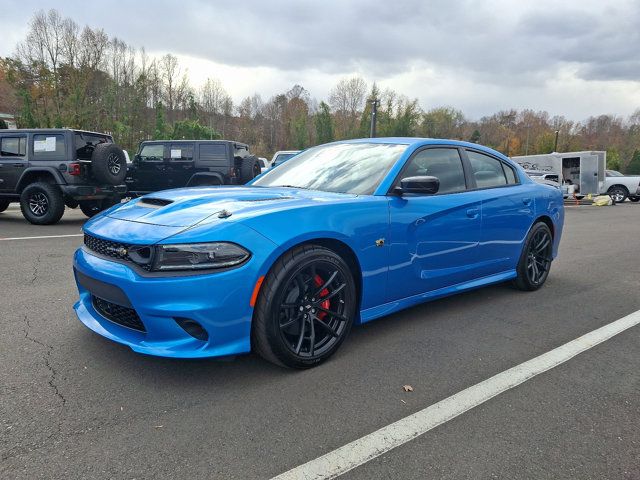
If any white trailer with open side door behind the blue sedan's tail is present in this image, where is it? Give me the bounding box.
[511,151,607,195]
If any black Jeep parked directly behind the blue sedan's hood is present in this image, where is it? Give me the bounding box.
[126,140,261,196]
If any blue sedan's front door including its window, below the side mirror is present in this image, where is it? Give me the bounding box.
[387,147,481,301]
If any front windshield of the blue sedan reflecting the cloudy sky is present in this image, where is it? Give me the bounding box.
[253,143,407,195]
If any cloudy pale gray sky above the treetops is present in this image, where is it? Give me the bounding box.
[0,0,640,118]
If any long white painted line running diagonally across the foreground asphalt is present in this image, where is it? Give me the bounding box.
[272,310,640,480]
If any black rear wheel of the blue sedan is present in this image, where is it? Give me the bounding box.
[513,222,553,292]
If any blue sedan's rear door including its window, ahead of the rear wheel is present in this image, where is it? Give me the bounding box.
[465,149,540,276]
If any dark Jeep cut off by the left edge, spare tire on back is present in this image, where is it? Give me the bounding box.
[0,129,127,225]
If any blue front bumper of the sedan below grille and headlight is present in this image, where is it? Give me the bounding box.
[73,247,259,358]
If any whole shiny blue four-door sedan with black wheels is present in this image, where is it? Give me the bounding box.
[74,138,564,368]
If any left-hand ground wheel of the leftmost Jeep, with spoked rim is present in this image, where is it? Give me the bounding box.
[20,182,64,225]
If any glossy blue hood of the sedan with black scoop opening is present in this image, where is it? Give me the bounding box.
[105,186,355,227]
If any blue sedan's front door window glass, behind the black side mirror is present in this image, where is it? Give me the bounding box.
[398,148,467,194]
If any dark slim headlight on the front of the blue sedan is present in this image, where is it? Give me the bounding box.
[153,242,251,271]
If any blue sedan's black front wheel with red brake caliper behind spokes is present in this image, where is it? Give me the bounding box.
[251,245,357,369]
